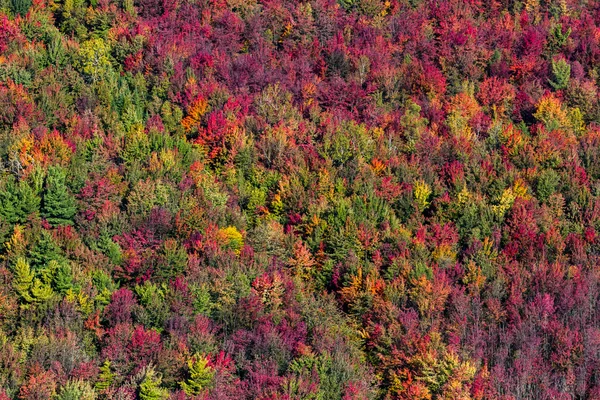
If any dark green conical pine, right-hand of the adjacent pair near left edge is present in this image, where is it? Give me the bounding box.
[42,167,77,226]
